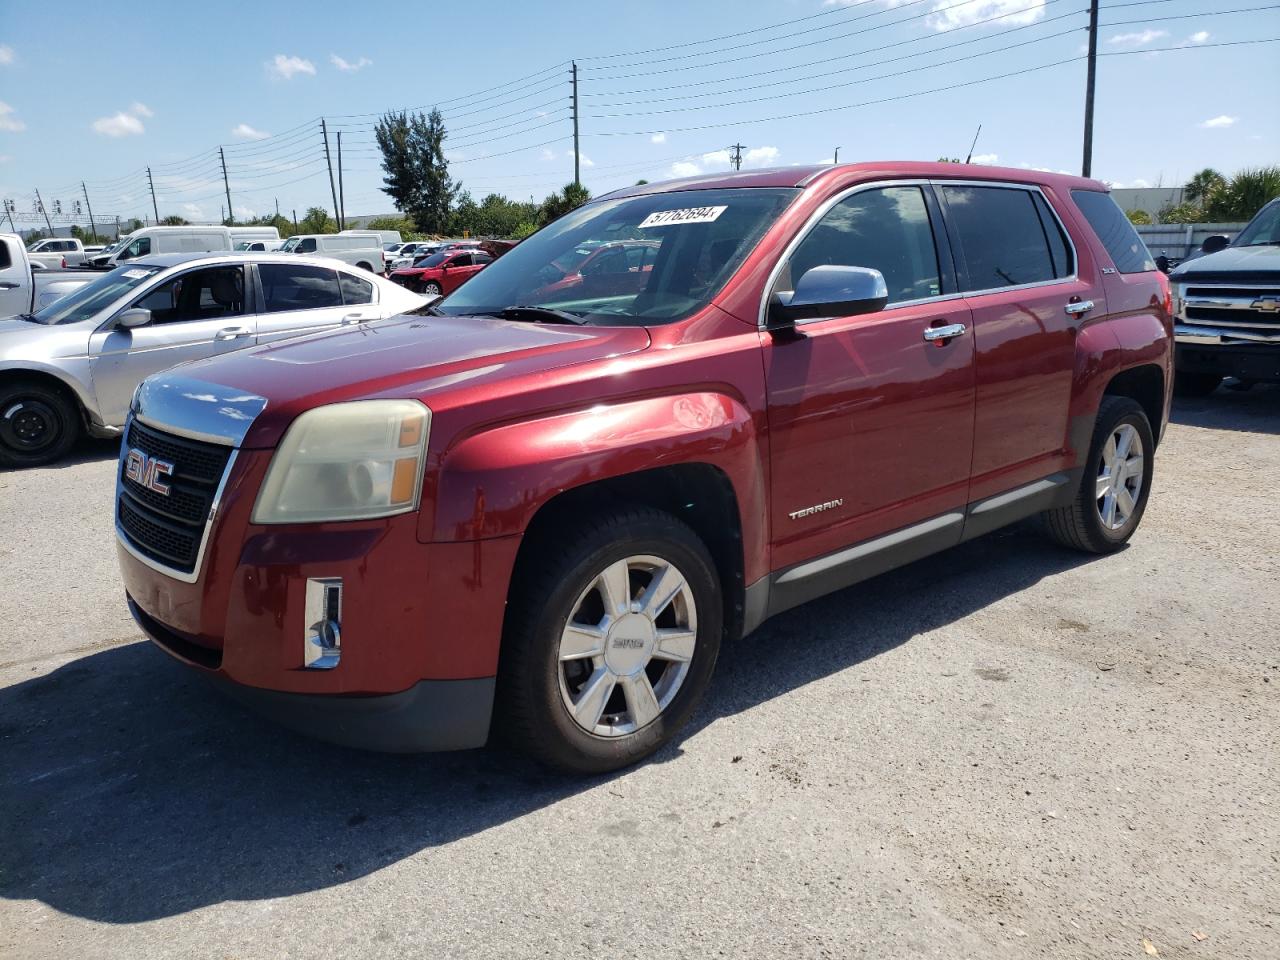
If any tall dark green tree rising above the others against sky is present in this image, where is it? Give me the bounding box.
[374,109,460,234]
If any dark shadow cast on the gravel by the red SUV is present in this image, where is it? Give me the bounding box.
[0,526,1088,923]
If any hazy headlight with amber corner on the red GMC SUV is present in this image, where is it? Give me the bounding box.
[253,399,431,524]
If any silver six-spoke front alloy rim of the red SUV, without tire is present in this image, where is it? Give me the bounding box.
[557,556,698,737]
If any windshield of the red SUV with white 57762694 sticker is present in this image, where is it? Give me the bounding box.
[435,188,799,326]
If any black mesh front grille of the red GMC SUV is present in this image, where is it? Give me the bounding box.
[115,421,232,573]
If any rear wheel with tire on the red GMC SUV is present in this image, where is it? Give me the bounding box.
[1043,397,1156,553]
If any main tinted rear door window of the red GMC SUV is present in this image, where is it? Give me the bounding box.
[942,187,1055,291]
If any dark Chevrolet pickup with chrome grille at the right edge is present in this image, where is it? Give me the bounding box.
[1170,200,1280,397]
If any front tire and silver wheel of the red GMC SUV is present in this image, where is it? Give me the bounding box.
[494,507,723,773]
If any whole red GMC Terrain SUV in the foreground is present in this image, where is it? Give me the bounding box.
[115,163,1172,771]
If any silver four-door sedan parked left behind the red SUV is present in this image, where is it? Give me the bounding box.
[0,252,425,467]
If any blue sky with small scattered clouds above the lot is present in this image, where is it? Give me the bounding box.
[0,0,1280,229]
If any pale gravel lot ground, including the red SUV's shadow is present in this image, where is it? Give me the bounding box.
[0,388,1280,960]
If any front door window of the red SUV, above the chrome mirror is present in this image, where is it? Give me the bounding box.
[774,187,942,303]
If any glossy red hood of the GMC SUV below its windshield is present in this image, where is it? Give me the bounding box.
[167,315,649,447]
